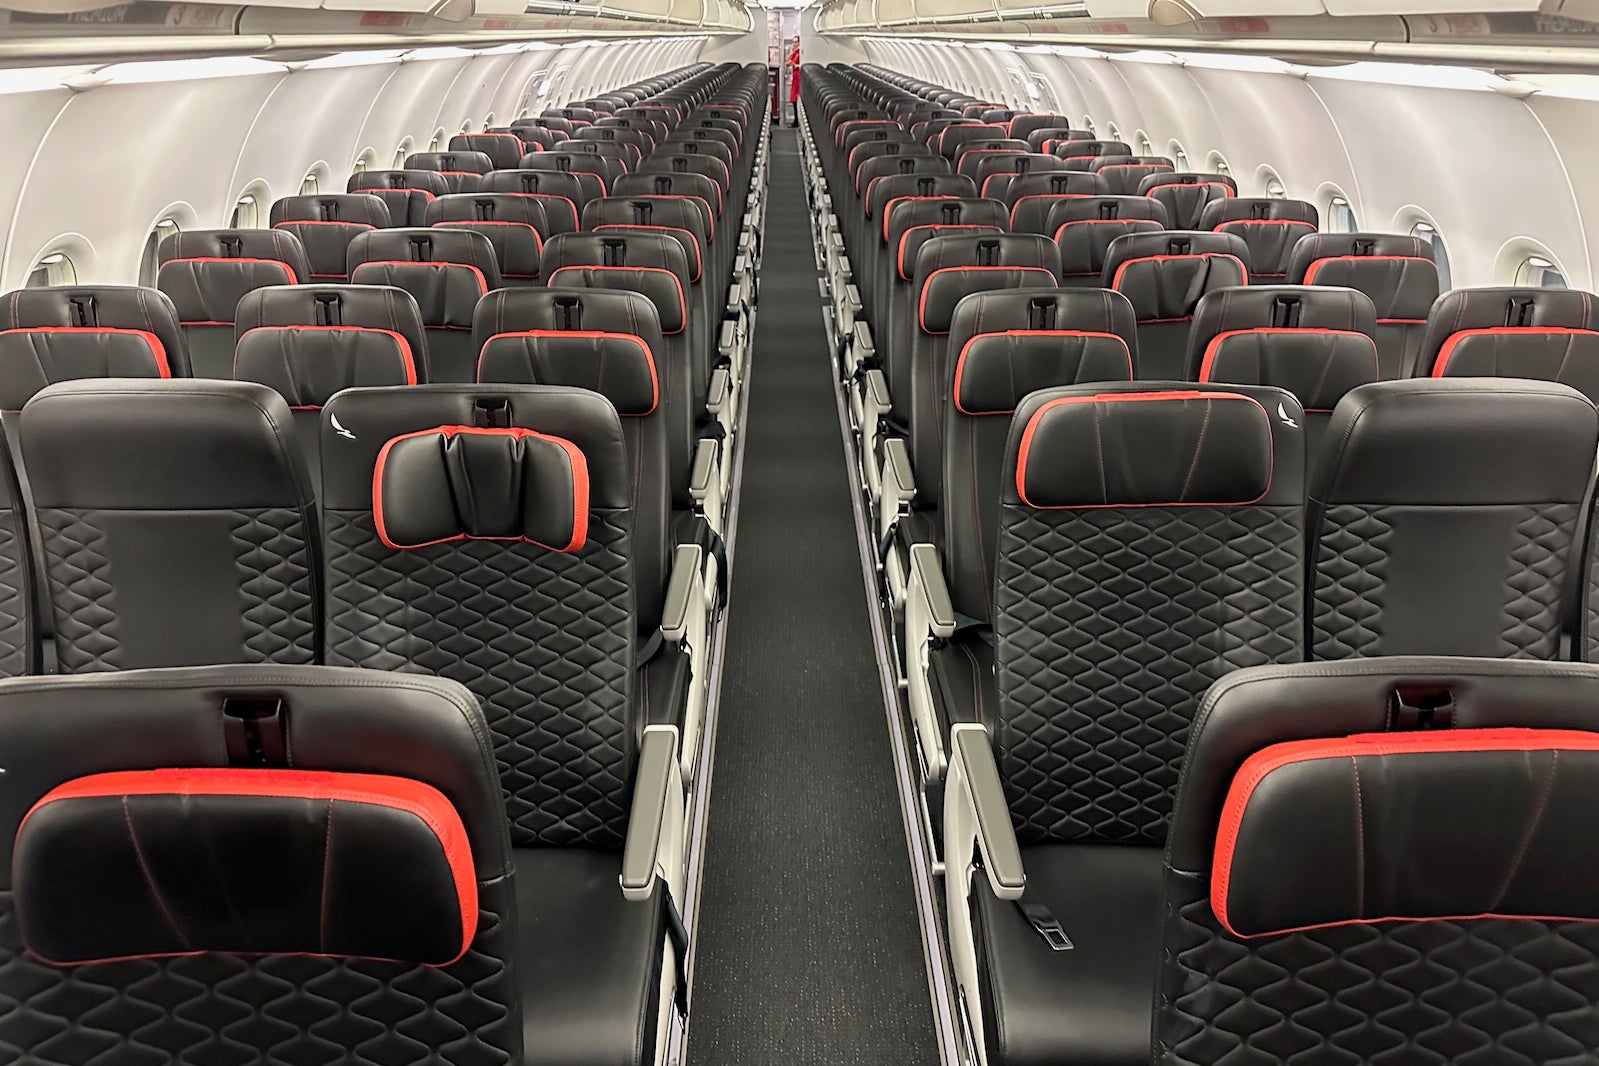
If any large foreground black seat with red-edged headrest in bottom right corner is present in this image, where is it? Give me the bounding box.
[1143,658,1599,1066]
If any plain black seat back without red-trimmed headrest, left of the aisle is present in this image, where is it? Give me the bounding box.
[18,379,321,673]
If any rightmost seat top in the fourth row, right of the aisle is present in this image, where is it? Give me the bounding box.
[1287,233,1438,323]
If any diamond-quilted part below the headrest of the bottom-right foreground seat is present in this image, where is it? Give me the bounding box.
[1154,871,1599,1066]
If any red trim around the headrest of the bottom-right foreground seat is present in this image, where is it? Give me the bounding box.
[1210,727,1599,940]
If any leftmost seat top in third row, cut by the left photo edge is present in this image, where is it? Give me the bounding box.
[0,284,192,383]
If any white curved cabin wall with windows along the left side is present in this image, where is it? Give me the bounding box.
[0,37,704,291]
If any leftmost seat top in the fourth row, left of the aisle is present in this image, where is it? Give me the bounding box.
[155,230,310,326]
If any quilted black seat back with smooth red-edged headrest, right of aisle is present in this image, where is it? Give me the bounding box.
[995,384,1305,845]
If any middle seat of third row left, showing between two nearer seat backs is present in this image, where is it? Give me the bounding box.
[233,284,427,497]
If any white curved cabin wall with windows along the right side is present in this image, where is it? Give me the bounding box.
[863,38,1599,289]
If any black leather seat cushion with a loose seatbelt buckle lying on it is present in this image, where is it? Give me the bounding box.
[972,844,1161,1066]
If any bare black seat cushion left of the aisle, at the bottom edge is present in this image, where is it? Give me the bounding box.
[515,847,665,1066]
